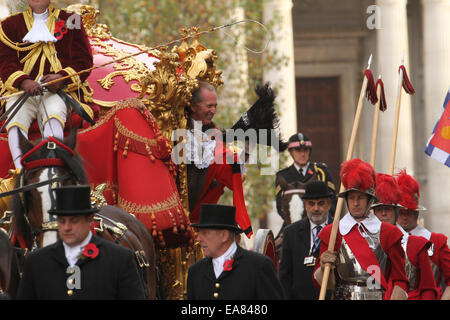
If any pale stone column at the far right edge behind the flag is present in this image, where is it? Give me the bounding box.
[421,0,450,236]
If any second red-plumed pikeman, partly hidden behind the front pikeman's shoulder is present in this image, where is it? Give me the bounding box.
[372,173,439,300]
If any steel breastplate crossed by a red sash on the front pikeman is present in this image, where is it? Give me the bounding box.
[334,232,387,300]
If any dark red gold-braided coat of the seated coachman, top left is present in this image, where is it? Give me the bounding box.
[0,5,94,118]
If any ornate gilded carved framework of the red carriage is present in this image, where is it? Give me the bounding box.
[68,4,223,299]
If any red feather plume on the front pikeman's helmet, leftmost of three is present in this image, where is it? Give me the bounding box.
[340,159,375,196]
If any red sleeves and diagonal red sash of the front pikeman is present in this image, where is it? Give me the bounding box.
[313,213,409,300]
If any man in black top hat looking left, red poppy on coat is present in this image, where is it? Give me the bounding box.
[187,204,284,300]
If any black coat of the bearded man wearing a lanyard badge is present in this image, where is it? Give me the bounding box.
[279,217,332,300]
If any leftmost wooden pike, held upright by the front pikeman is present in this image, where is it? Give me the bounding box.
[319,55,377,300]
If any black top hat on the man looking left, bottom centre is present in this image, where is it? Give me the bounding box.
[191,203,243,233]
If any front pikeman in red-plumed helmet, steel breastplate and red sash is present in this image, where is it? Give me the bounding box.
[313,159,409,300]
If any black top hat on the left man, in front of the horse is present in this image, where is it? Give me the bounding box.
[48,185,99,216]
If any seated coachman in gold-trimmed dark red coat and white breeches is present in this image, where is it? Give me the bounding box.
[0,0,94,169]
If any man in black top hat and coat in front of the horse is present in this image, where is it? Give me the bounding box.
[17,186,145,300]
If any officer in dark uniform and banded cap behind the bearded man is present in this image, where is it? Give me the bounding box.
[275,132,337,225]
